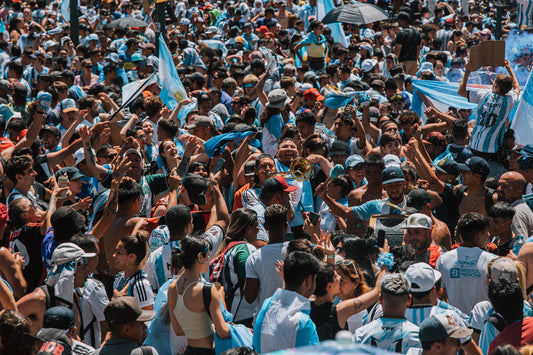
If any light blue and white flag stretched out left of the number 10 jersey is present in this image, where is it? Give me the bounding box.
[412,80,480,123]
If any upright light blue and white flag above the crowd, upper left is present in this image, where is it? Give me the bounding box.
[159,34,187,110]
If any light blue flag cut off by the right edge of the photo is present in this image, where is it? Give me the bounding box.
[511,69,533,145]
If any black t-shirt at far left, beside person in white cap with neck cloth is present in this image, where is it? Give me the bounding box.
[11,223,46,293]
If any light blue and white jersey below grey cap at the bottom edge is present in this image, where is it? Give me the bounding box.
[354,318,422,354]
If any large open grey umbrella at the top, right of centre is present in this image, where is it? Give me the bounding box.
[322,2,389,25]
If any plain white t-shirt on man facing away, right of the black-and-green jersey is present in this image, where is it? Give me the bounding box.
[246,242,289,317]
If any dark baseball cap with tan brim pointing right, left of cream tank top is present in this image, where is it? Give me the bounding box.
[104,296,155,324]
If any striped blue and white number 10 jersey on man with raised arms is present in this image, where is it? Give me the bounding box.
[468,90,518,153]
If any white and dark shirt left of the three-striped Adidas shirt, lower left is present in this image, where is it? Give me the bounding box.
[81,278,109,348]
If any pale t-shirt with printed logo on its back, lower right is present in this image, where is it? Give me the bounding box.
[436,247,496,314]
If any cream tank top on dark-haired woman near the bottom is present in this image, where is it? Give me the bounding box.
[174,281,215,339]
